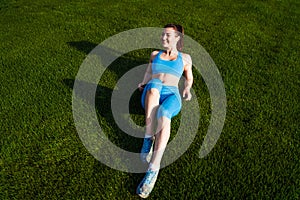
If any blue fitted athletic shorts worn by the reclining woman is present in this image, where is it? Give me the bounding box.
[142,79,182,119]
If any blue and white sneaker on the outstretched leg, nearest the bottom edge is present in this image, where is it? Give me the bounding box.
[136,170,159,198]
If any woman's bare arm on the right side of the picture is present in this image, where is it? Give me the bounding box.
[182,54,194,101]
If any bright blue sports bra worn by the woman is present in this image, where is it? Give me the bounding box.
[152,51,183,78]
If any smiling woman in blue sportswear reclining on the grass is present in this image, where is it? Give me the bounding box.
[137,24,193,198]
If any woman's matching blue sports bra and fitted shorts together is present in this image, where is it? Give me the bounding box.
[142,51,183,119]
